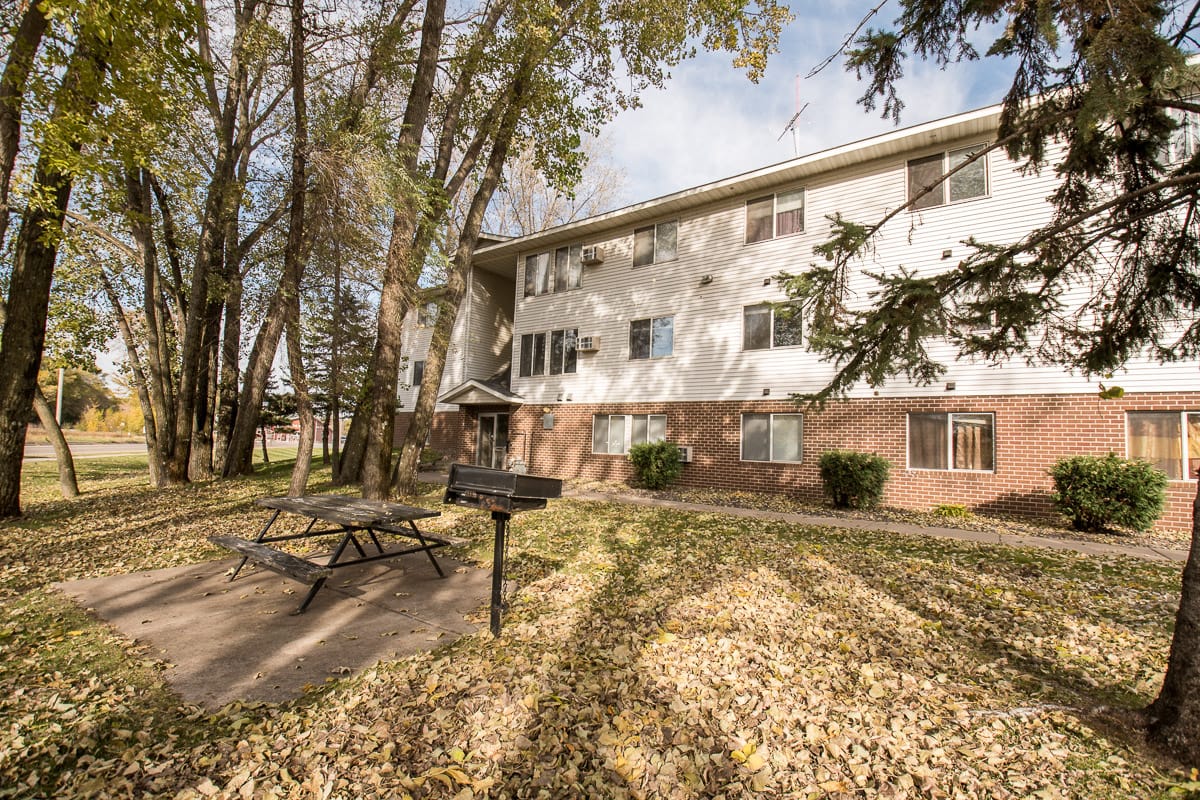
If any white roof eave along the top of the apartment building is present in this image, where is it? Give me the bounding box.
[474,106,1001,277]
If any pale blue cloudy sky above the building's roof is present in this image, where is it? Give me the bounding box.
[602,0,1012,205]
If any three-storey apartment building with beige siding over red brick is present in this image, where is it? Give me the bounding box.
[397,107,1200,528]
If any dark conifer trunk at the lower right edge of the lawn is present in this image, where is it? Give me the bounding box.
[1146,474,1200,766]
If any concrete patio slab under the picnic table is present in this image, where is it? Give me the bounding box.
[55,553,491,709]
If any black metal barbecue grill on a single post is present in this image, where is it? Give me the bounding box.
[442,464,563,636]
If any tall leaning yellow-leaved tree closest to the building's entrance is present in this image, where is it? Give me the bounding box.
[372,0,791,497]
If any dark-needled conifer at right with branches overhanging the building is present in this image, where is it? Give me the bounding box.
[786,0,1200,764]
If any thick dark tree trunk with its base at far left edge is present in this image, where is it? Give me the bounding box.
[0,31,108,517]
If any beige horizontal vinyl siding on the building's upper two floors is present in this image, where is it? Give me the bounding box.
[512,137,1194,404]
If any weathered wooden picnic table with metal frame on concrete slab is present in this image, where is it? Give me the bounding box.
[209,494,462,614]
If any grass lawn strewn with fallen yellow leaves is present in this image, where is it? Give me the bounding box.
[0,458,1198,800]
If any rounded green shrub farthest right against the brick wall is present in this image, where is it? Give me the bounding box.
[1050,453,1166,531]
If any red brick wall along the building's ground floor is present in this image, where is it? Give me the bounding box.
[480,392,1200,528]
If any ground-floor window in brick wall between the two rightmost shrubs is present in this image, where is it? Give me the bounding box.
[908,414,996,473]
